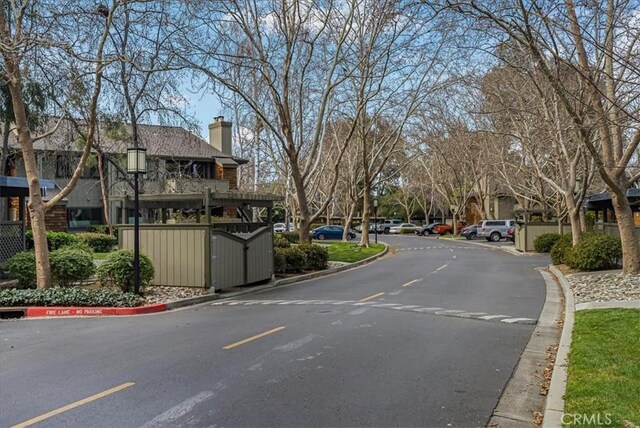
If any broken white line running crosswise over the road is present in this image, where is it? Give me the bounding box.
[211,300,537,325]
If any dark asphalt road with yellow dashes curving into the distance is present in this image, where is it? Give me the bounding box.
[0,236,548,427]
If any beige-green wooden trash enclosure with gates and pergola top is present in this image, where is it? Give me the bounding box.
[112,190,279,291]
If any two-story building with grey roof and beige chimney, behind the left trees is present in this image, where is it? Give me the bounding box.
[0,116,247,230]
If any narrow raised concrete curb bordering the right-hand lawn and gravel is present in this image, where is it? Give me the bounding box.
[542,265,575,428]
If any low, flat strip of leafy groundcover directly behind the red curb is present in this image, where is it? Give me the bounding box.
[0,287,141,308]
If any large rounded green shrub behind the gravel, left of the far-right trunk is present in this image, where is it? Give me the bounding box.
[565,233,622,270]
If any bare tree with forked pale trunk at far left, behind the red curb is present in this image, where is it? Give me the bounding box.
[0,0,119,288]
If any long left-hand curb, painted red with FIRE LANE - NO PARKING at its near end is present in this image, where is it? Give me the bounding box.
[7,242,389,318]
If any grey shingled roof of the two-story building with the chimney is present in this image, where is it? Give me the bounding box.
[9,120,247,164]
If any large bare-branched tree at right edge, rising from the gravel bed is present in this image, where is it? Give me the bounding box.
[449,0,640,273]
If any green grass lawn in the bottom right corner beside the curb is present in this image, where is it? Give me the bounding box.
[565,309,640,427]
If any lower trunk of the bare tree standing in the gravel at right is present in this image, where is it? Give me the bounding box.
[611,192,640,274]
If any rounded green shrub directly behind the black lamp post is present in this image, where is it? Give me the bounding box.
[98,250,155,293]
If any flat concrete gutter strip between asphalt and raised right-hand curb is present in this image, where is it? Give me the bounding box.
[487,269,563,428]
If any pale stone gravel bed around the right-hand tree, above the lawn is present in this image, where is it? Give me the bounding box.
[567,272,640,303]
